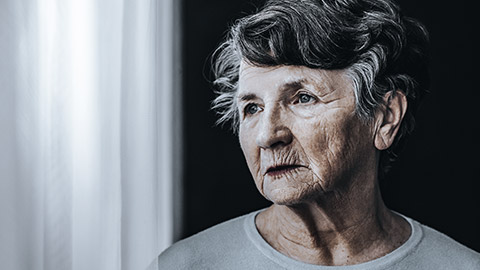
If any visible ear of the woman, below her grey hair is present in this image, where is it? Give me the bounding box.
[374,91,407,150]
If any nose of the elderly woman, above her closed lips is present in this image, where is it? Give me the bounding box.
[256,106,293,149]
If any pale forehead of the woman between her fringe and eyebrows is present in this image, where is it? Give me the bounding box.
[238,61,350,94]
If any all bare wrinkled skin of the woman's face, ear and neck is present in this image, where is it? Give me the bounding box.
[237,62,410,265]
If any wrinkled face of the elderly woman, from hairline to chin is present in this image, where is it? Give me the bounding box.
[237,62,375,205]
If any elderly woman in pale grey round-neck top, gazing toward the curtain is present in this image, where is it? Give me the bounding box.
[159,0,480,270]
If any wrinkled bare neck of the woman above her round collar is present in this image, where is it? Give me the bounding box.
[256,181,410,265]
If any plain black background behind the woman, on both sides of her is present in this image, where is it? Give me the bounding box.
[182,0,480,251]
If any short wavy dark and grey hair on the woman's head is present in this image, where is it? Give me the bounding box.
[212,0,429,175]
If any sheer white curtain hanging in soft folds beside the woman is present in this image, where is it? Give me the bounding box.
[0,0,181,270]
